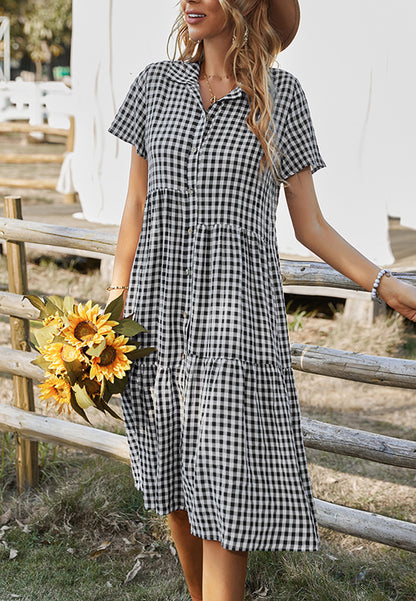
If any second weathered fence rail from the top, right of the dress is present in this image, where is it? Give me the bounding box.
[291,343,416,389]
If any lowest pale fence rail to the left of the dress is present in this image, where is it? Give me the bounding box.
[0,403,130,463]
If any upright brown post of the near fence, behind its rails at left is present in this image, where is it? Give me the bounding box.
[4,196,39,493]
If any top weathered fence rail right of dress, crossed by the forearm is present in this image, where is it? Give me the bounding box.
[280,259,416,292]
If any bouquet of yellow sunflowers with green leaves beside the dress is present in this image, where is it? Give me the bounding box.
[26,294,157,422]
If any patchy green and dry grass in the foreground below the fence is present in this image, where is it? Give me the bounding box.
[0,445,416,601]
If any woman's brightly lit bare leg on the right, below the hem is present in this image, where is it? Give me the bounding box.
[202,539,248,601]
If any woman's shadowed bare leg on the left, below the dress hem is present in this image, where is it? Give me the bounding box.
[168,509,202,601]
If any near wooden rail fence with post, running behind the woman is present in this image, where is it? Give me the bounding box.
[0,197,416,552]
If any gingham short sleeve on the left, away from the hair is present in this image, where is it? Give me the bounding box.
[108,65,150,159]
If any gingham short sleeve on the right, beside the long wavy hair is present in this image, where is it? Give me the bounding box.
[279,78,326,180]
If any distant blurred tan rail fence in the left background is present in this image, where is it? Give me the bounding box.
[0,116,75,204]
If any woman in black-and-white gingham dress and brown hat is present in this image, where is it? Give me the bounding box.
[109,0,416,601]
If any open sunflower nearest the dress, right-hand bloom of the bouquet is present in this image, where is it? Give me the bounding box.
[90,332,136,382]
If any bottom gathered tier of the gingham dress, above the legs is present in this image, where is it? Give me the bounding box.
[123,355,320,551]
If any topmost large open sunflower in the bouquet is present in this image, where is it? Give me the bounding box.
[62,300,118,347]
